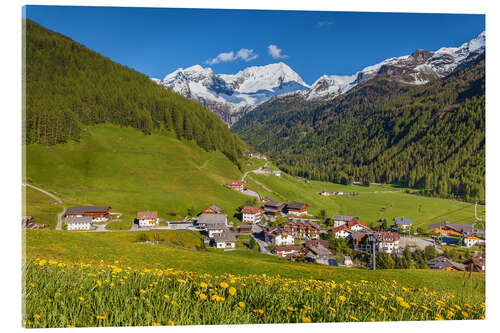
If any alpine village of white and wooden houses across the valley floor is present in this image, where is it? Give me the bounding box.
[22,172,486,272]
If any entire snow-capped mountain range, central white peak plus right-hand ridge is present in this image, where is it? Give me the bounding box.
[152,31,486,125]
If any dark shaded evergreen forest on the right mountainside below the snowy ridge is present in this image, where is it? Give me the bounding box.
[232,56,485,201]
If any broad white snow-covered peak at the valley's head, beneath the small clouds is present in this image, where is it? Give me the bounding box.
[153,62,310,124]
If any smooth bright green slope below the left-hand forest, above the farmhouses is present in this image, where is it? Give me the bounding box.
[26,125,248,221]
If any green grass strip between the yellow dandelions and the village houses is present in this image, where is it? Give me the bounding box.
[26,230,484,295]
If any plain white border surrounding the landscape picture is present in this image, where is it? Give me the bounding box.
[0,0,500,333]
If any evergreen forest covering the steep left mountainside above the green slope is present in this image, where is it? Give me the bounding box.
[23,19,244,164]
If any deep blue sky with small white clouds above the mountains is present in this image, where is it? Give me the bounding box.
[25,6,485,84]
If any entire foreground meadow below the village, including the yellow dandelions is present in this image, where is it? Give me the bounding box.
[23,230,484,327]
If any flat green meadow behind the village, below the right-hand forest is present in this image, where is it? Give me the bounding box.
[246,167,485,228]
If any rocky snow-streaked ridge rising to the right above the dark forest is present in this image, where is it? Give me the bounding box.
[300,31,486,99]
